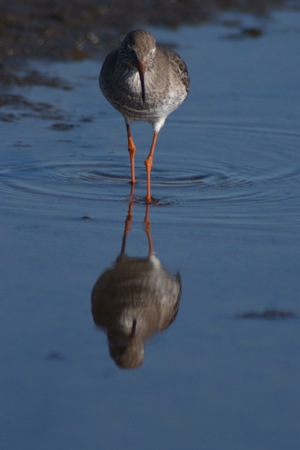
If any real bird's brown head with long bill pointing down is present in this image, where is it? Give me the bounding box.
[121,30,156,102]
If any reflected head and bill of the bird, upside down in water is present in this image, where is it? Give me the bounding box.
[108,319,144,369]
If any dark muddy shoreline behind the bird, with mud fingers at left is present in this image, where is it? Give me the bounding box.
[0,0,299,117]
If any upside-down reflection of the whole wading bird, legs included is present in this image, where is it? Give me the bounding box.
[92,193,181,369]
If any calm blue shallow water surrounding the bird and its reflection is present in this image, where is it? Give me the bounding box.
[0,12,300,450]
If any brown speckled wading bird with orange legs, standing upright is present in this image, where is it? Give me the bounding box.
[99,30,190,203]
